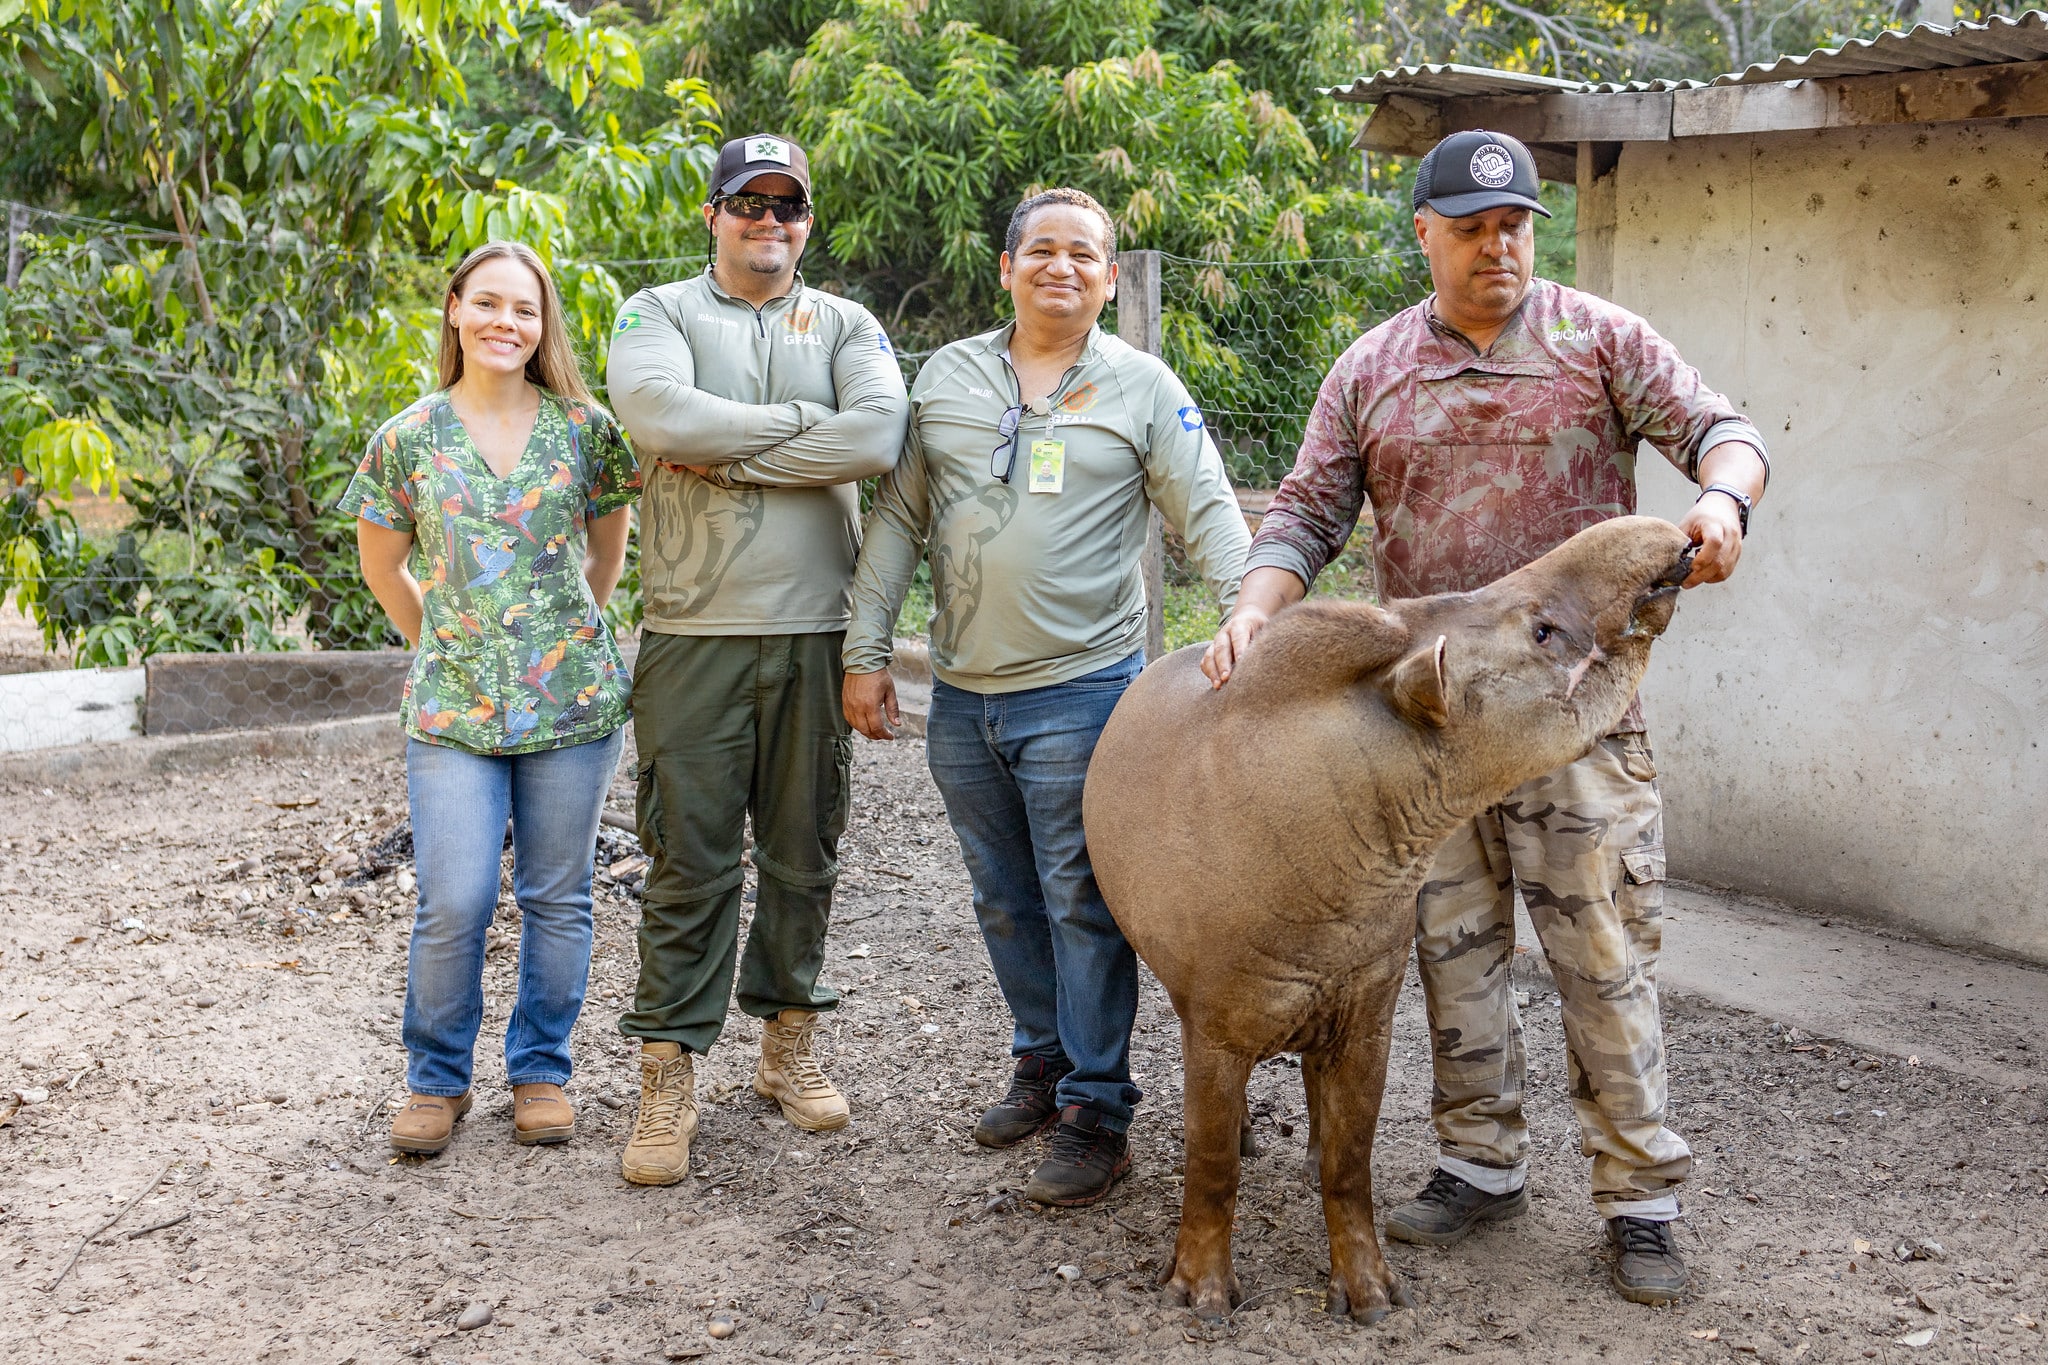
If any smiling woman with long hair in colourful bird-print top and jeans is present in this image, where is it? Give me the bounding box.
[342,241,639,1152]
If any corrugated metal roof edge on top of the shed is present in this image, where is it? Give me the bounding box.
[1321,10,2048,104]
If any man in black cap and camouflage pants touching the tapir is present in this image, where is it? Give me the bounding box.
[1202,131,1769,1304]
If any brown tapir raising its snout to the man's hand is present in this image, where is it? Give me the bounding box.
[1083,516,1694,1322]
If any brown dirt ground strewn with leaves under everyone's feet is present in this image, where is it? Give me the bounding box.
[0,741,2048,1365]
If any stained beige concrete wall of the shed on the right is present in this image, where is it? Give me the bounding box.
[1593,119,2048,962]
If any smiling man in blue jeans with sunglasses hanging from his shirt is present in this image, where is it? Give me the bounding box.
[846,190,1251,1205]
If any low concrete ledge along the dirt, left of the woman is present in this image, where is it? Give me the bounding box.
[0,714,406,794]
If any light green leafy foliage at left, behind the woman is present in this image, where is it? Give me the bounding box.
[0,0,715,663]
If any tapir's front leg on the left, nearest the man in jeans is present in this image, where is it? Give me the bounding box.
[1165,1021,1251,1322]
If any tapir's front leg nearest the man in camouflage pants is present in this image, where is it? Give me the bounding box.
[1303,994,1409,1324]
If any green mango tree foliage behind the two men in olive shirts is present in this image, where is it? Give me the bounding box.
[638,0,1419,485]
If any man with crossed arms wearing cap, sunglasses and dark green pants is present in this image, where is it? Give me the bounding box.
[606,135,907,1185]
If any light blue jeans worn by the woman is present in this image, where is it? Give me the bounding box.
[403,729,625,1095]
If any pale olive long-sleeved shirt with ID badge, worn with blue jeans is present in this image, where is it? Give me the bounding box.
[846,325,1251,694]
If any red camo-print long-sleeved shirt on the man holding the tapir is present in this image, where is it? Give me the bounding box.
[1245,278,1763,731]
